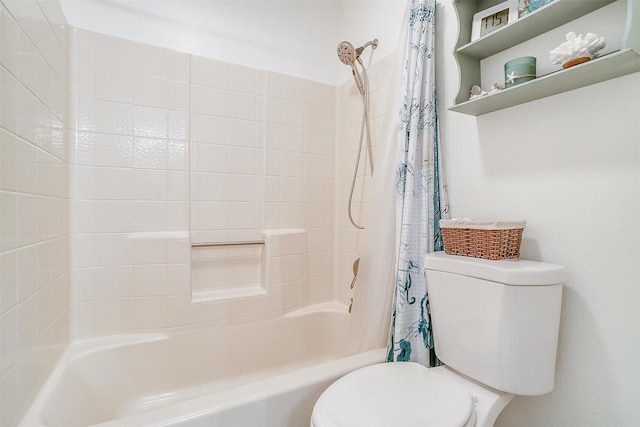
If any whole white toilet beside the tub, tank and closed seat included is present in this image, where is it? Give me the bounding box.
[311,252,567,427]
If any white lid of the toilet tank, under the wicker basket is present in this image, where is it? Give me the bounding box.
[424,252,569,286]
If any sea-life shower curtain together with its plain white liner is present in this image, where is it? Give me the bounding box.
[349,0,448,366]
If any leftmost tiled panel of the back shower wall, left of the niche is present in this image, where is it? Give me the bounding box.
[71,30,190,336]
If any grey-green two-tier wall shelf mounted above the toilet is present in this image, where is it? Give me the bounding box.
[449,0,640,116]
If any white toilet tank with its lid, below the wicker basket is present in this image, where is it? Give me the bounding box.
[424,252,567,395]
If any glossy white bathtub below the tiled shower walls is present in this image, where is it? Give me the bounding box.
[21,310,385,427]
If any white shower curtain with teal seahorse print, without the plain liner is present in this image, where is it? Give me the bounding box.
[387,0,448,366]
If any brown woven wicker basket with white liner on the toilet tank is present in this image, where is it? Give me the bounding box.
[440,220,525,260]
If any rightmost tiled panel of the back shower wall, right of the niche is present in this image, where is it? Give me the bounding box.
[264,73,335,309]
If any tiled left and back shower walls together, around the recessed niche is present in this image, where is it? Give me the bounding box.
[0,13,390,425]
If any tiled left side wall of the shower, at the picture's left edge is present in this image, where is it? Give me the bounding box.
[0,1,69,426]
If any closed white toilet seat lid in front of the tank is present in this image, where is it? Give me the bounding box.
[311,362,475,427]
